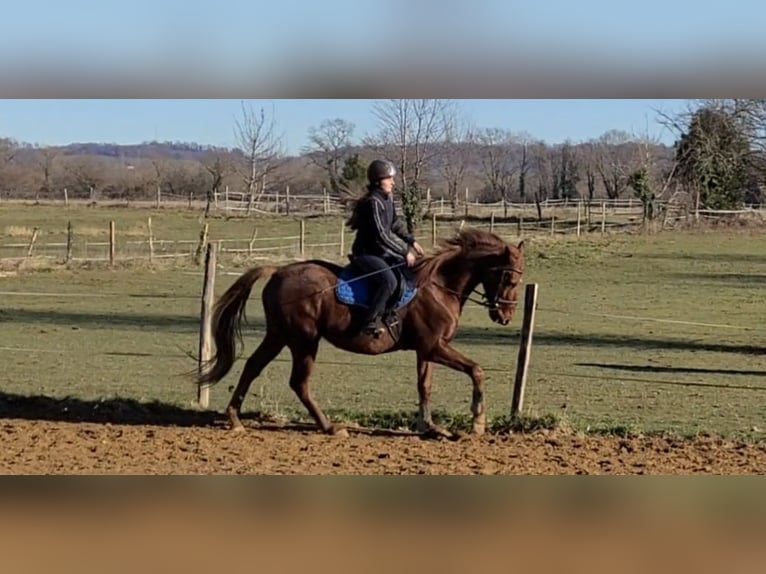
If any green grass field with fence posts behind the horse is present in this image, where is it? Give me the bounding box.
[0,205,766,440]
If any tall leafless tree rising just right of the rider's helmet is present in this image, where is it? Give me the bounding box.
[371,99,453,232]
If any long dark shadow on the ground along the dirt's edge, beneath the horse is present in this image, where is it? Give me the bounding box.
[0,391,418,436]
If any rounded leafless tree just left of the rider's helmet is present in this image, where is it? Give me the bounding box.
[303,118,356,195]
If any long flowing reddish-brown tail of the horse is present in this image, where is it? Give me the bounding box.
[197,265,277,385]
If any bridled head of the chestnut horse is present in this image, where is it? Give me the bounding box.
[480,241,524,325]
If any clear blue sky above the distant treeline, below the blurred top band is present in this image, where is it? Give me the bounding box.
[0,99,685,154]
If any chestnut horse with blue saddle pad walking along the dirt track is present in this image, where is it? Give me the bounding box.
[196,228,524,437]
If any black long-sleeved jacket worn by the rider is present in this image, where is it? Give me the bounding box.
[351,188,415,259]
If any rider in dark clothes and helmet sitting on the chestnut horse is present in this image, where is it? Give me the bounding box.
[347,159,423,337]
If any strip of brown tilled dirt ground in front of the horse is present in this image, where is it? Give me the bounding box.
[0,418,766,475]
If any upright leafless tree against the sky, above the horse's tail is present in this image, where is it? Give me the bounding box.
[234,102,284,207]
